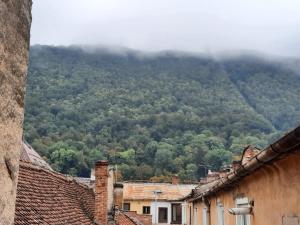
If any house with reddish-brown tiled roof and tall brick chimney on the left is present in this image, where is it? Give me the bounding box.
[14,143,151,225]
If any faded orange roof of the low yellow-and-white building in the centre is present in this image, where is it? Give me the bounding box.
[123,183,197,201]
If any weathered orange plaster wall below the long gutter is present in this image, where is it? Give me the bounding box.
[194,150,300,225]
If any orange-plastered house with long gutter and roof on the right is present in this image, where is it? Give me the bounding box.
[185,126,300,225]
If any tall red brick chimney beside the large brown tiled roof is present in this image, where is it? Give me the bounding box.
[95,161,108,225]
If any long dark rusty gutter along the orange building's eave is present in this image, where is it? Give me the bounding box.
[191,126,300,201]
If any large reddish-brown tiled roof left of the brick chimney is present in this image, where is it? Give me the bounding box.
[15,161,95,225]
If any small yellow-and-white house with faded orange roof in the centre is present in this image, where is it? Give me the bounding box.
[123,176,197,224]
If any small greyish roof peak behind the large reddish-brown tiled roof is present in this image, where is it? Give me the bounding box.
[20,141,52,170]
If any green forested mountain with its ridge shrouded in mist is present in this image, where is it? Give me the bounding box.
[25,46,300,179]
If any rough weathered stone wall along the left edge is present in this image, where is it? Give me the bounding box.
[0,0,31,225]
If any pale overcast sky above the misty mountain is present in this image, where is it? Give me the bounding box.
[31,0,300,57]
